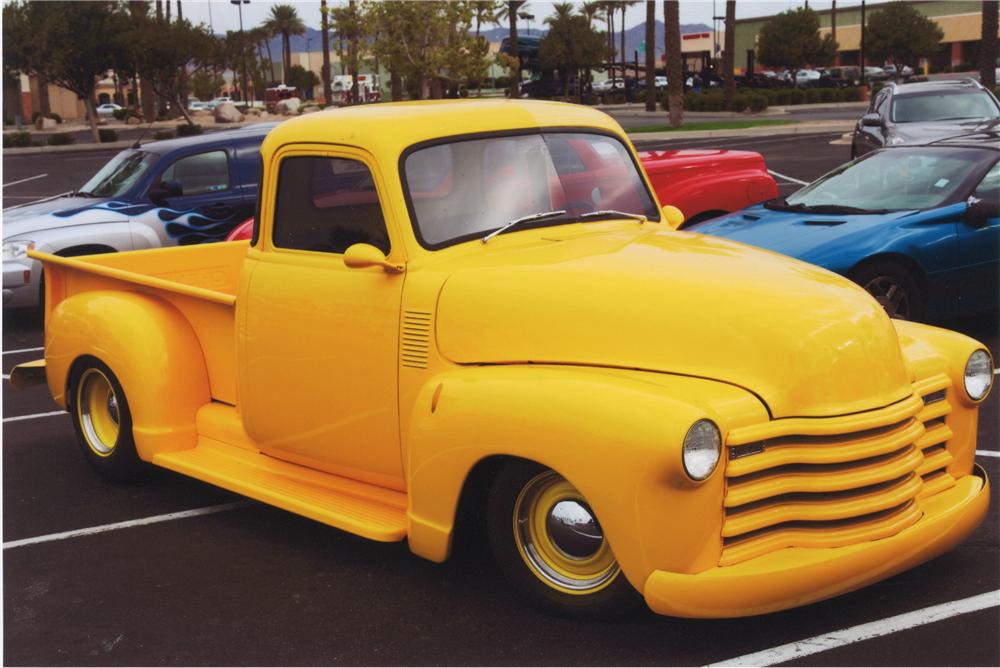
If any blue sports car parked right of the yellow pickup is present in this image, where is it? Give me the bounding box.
[689,131,1000,321]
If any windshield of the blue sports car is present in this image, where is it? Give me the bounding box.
[775,148,993,213]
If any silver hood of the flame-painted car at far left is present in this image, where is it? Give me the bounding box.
[3,197,131,239]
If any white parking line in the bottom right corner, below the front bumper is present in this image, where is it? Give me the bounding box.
[709,589,1000,666]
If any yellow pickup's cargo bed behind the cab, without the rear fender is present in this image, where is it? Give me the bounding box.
[32,242,247,405]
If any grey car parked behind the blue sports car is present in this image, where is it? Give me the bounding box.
[851,79,1000,157]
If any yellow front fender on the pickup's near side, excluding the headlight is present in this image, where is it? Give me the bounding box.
[407,365,767,589]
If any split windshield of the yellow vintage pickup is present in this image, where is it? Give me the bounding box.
[403,132,660,248]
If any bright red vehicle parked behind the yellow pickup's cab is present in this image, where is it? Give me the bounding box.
[226,149,778,241]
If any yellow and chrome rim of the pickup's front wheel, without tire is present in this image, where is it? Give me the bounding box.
[513,471,619,595]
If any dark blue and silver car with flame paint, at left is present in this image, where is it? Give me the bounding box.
[3,123,276,307]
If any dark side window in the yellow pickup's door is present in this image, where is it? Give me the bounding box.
[272,156,389,255]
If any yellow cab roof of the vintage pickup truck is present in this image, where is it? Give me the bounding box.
[262,100,623,159]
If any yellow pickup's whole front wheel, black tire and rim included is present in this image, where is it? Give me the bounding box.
[487,462,641,618]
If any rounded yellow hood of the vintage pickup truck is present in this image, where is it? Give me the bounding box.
[436,228,912,418]
